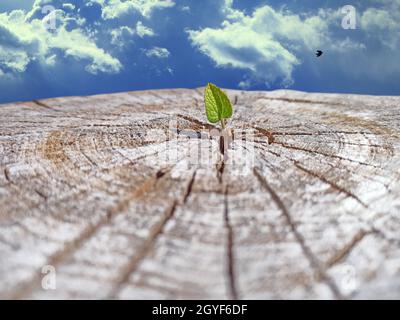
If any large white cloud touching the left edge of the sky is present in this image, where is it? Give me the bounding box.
[0,5,122,74]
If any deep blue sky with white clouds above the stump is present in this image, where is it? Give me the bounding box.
[0,0,400,103]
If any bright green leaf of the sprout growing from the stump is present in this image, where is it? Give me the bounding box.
[204,83,233,123]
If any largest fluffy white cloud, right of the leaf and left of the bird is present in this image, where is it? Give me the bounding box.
[189,0,328,86]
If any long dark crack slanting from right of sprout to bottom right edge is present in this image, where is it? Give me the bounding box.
[253,168,343,299]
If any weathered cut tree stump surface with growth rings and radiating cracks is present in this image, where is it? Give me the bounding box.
[0,89,400,299]
